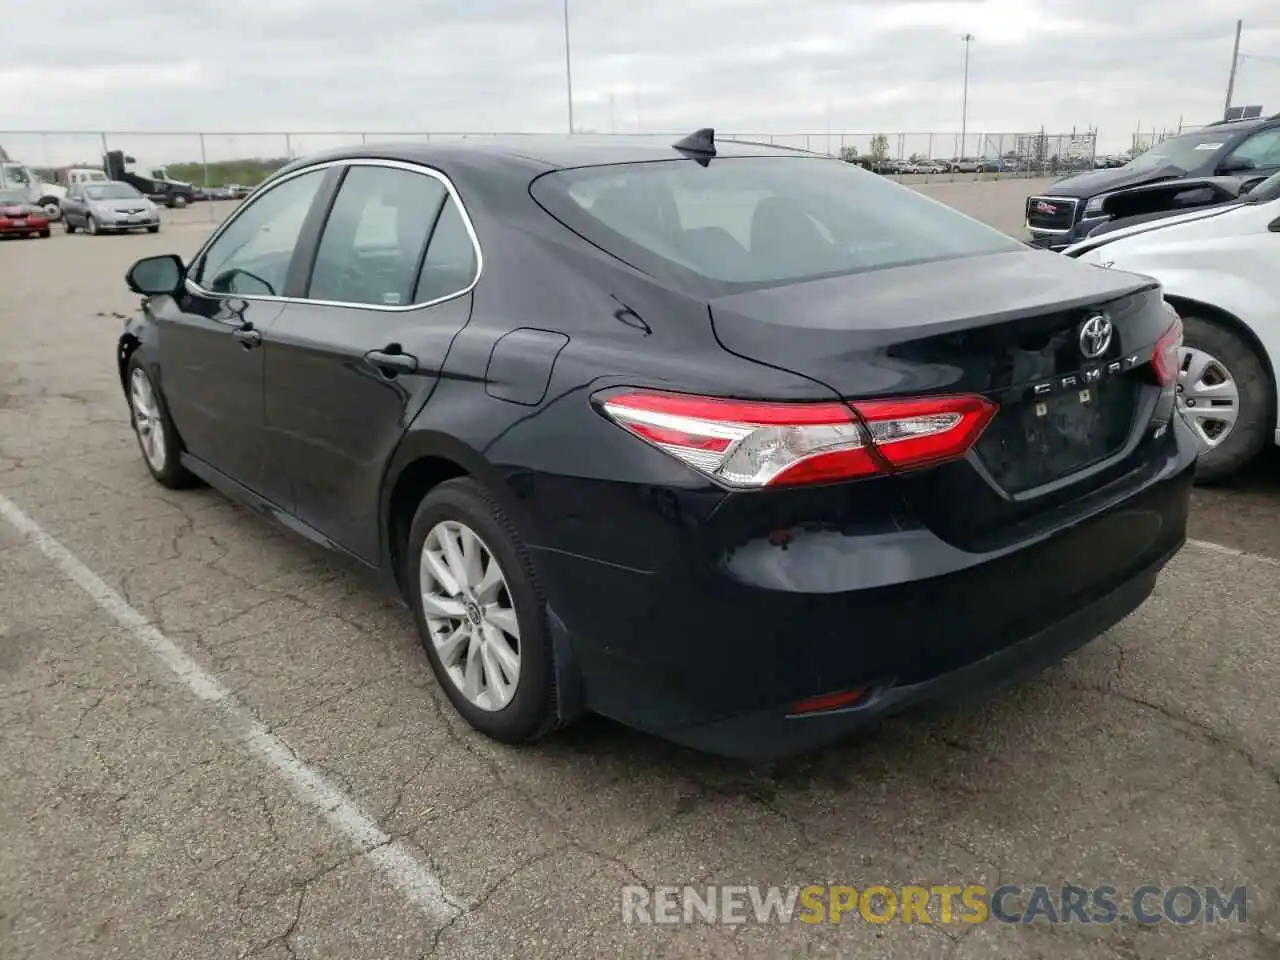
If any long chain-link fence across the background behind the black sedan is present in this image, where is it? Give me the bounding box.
[0,131,1097,202]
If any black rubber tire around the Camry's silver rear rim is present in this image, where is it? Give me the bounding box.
[403,477,557,745]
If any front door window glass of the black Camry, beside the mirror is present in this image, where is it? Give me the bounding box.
[192,169,328,297]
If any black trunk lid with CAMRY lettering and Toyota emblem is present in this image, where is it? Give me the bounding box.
[710,251,1171,549]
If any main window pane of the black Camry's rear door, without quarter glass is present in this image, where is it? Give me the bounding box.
[307,165,455,306]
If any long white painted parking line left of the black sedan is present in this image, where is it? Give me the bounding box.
[0,494,462,923]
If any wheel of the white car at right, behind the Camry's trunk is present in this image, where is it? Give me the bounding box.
[1178,316,1274,483]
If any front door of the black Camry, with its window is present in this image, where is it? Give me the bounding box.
[156,163,326,508]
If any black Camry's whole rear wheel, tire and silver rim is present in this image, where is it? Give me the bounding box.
[403,477,557,744]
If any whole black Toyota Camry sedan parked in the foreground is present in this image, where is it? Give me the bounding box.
[116,131,1196,758]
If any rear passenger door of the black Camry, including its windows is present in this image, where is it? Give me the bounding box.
[265,161,480,562]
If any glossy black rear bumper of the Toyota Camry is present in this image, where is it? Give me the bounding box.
[536,432,1194,759]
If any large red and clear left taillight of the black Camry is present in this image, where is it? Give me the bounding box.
[602,390,996,488]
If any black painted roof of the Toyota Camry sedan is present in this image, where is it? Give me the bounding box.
[276,133,822,170]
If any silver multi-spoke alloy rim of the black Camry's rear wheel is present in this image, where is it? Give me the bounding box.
[419,520,521,712]
